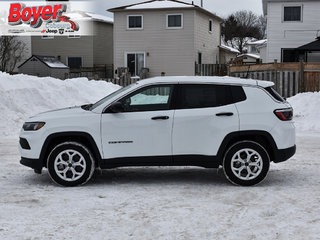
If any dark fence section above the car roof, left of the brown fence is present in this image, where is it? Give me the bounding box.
[195,63,228,76]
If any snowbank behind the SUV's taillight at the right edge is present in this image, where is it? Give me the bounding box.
[288,92,320,133]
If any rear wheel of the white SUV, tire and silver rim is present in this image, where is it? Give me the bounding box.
[223,141,270,186]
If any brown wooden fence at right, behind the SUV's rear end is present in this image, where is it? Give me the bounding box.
[229,61,320,97]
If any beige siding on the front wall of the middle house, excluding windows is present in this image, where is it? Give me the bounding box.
[114,10,194,77]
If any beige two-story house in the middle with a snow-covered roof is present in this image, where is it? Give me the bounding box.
[109,0,223,77]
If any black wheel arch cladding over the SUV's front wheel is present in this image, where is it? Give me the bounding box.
[40,132,102,167]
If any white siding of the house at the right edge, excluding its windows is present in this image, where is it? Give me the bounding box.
[267,1,320,62]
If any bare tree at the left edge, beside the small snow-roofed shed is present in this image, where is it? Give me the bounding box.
[0,36,26,73]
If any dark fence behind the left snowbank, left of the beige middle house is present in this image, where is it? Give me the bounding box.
[68,64,113,79]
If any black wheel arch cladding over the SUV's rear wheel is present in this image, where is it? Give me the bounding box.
[217,131,278,164]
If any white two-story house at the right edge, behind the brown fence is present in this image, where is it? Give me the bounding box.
[262,0,320,62]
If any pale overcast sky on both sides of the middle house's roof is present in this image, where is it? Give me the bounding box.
[92,0,262,17]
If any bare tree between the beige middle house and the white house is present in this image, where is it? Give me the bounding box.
[222,10,265,53]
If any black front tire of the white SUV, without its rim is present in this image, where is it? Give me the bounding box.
[48,143,94,187]
